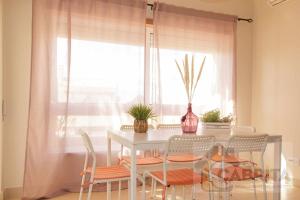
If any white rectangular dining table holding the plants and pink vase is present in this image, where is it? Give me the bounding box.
[107,129,282,200]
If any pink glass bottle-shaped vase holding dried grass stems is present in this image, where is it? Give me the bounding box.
[181,103,199,133]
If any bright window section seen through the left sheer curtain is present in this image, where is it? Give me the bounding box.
[54,38,144,151]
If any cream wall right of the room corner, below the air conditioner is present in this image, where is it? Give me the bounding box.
[252,0,300,179]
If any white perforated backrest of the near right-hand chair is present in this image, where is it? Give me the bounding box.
[227,134,268,153]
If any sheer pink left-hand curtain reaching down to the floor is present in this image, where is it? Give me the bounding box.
[23,0,146,199]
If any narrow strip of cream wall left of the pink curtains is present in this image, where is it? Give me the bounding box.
[3,0,31,187]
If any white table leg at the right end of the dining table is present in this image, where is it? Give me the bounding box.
[273,140,282,200]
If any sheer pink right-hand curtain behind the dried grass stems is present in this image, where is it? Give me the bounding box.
[151,3,237,123]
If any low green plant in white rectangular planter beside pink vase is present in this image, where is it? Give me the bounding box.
[200,109,232,129]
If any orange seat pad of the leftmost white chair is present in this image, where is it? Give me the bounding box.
[85,165,130,180]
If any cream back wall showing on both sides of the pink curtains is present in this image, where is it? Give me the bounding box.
[3,0,253,187]
